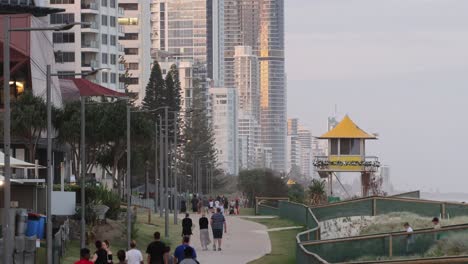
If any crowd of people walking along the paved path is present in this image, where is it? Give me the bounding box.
[75,195,241,264]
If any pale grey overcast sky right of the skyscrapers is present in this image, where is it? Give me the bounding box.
[285,0,468,193]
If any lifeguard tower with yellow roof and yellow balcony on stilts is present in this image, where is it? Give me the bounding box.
[314,115,380,196]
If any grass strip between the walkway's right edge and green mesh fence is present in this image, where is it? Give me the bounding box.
[247,216,305,264]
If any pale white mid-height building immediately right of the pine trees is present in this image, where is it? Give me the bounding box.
[208,87,239,175]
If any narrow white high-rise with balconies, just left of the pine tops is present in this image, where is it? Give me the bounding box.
[118,0,152,102]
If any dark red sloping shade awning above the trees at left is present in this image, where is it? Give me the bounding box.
[60,79,125,101]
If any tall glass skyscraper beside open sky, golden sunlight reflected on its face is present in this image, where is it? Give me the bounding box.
[259,0,287,171]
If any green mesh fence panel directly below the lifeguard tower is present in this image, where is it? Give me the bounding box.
[312,199,372,221]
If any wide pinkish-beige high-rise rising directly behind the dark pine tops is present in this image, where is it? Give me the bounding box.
[151,0,224,84]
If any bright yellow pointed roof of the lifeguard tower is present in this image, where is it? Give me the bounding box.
[319,115,377,139]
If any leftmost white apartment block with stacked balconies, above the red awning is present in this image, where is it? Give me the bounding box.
[50,0,124,90]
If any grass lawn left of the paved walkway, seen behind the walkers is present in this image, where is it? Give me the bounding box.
[61,213,182,264]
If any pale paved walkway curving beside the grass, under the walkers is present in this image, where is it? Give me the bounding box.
[183,214,271,264]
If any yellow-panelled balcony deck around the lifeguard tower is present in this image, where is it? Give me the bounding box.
[313,155,380,175]
